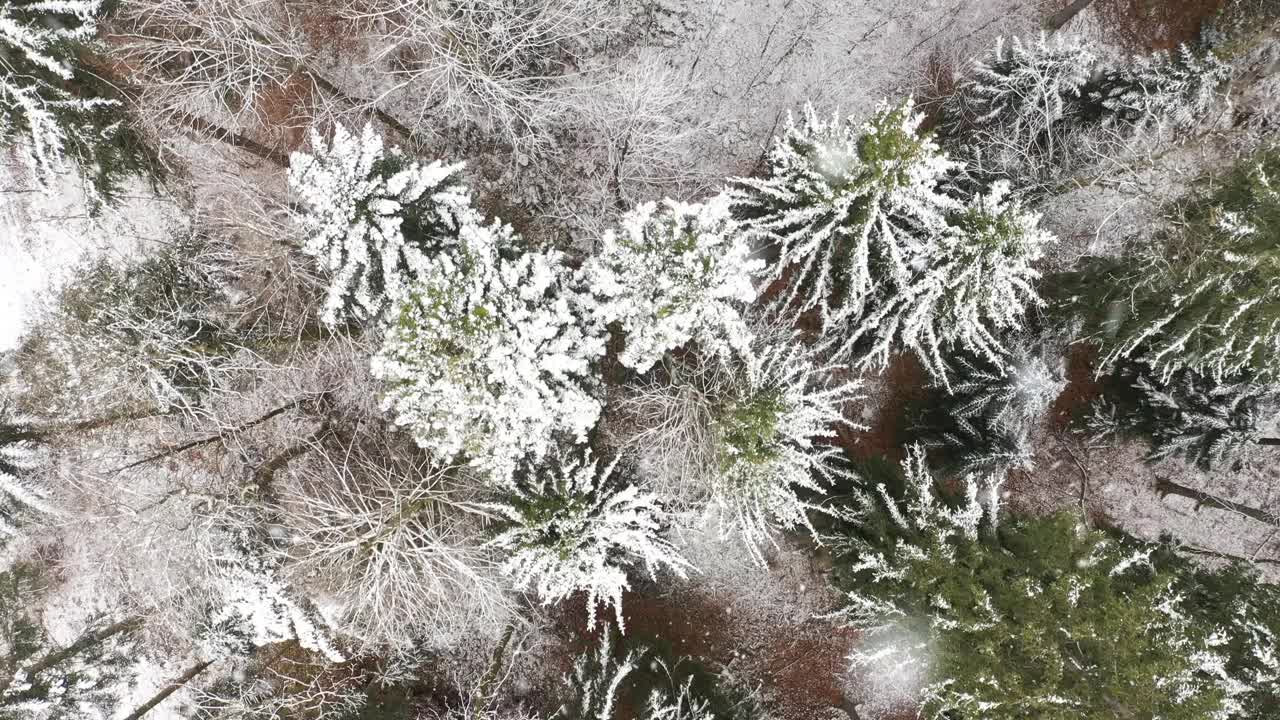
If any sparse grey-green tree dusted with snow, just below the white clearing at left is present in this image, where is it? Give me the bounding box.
[19,231,238,418]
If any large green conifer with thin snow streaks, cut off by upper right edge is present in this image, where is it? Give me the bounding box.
[1091,149,1280,383]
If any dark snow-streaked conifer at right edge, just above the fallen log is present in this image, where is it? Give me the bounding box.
[1089,363,1280,469]
